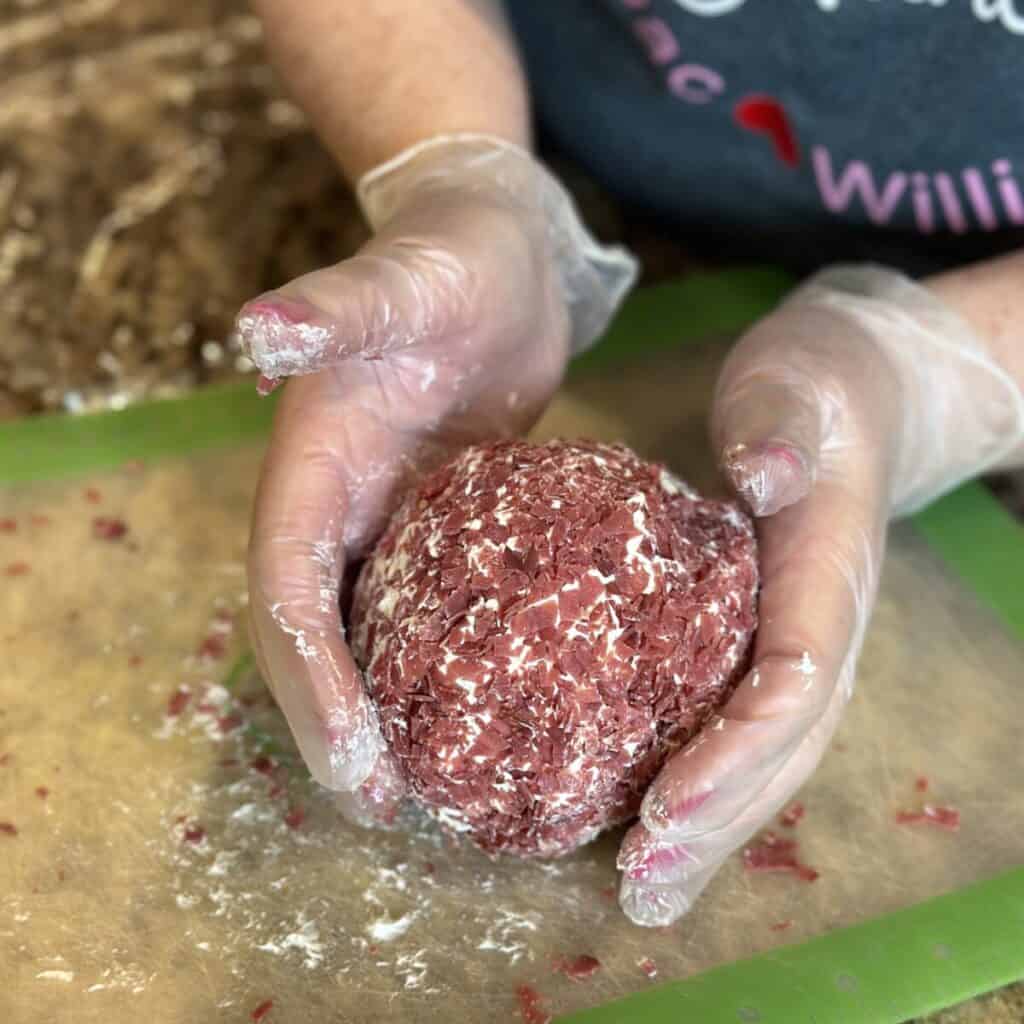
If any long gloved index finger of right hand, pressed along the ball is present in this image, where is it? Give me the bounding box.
[641,468,884,841]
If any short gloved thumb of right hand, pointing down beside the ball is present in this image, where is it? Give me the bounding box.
[712,318,837,516]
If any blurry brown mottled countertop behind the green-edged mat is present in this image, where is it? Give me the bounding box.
[0,0,1024,517]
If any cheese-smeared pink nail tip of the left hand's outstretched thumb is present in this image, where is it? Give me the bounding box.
[234,292,334,380]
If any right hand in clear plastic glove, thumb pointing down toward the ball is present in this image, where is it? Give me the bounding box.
[620,266,1024,926]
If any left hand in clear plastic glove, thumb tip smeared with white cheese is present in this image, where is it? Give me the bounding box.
[237,136,635,823]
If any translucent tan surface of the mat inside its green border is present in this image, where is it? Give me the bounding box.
[0,347,1024,1024]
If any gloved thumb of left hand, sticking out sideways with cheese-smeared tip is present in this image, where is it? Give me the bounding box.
[236,235,468,382]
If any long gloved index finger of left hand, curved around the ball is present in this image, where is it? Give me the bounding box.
[249,381,393,791]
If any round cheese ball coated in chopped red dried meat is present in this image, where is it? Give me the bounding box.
[351,441,758,857]
